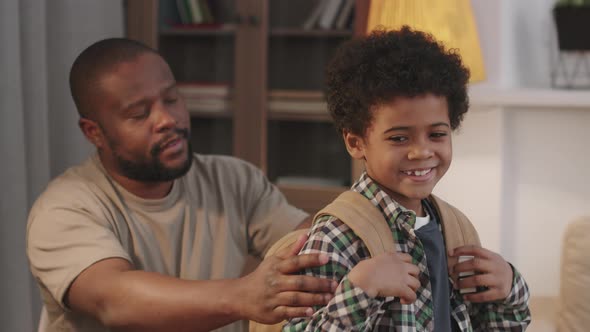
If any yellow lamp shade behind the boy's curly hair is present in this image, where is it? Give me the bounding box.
[367,0,485,82]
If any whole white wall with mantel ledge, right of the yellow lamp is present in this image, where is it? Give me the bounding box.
[436,0,590,296]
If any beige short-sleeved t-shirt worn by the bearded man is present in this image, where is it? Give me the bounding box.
[27,154,306,332]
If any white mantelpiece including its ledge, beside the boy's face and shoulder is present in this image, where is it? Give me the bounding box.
[436,92,590,296]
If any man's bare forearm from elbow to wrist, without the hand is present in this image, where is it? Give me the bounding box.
[77,271,244,332]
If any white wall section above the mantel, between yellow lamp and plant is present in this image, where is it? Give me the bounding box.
[471,0,557,88]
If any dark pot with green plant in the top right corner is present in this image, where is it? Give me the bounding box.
[553,0,590,51]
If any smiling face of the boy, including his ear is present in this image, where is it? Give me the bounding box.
[344,94,452,215]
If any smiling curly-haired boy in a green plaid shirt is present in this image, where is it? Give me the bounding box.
[284,27,530,331]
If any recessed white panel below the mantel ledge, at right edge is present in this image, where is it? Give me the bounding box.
[509,109,590,295]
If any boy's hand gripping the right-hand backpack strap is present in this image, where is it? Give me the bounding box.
[452,246,514,302]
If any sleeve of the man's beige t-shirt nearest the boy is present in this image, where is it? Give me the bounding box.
[237,161,308,257]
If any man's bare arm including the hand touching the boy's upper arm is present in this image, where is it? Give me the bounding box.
[64,241,336,332]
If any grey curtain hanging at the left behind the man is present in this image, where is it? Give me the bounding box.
[0,0,124,331]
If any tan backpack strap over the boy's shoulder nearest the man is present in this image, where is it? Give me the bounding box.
[314,190,395,257]
